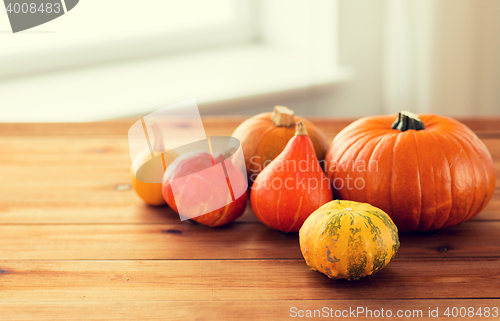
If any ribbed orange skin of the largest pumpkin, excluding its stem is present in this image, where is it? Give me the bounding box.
[326,115,495,232]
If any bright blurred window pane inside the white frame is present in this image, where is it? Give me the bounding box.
[0,0,257,79]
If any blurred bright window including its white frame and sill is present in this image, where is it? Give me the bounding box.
[0,0,351,122]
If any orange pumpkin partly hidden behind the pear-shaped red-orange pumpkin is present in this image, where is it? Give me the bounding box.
[232,106,328,185]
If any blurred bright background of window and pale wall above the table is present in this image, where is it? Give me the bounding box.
[0,0,500,121]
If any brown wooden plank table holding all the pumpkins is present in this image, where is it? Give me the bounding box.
[0,117,500,321]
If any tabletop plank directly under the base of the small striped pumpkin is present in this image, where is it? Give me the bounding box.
[0,258,500,304]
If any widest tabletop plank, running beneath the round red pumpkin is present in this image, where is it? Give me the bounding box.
[0,136,500,224]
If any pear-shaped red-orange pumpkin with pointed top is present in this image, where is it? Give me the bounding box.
[250,121,332,232]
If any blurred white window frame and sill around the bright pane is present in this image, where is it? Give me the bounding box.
[0,0,353,122]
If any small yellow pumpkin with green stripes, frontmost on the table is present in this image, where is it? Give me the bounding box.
[299,200,399,281]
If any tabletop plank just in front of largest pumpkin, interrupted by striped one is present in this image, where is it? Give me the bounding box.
[0,222,500,260]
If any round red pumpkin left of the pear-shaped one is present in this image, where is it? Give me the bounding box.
[163,152,248,227]
